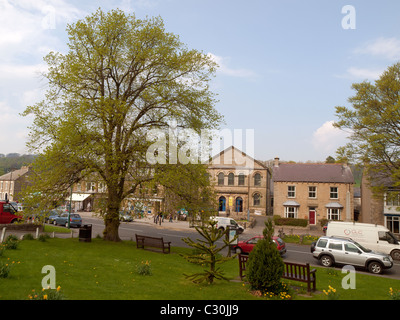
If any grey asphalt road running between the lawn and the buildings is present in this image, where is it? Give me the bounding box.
[78,217,400,279]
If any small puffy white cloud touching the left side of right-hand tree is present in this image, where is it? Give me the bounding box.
[312,120,349,155]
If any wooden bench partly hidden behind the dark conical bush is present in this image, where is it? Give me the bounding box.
[239,254,317,292]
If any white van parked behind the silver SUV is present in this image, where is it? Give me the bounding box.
[326,221,400,260]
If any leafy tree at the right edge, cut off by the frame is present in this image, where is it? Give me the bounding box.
[335,63,400,191]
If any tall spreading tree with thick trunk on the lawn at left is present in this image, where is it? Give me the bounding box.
[23,9,221,241]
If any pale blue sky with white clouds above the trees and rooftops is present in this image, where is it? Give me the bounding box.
[0,0,400,161]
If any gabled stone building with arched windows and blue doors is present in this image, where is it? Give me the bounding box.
[208,146,272,217]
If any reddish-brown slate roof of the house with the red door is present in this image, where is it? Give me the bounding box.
[272,163,354,183]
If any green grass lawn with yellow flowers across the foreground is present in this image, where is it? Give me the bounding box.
[0,238,400,300]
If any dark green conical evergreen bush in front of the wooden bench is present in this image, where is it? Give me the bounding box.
[247,220,284,294]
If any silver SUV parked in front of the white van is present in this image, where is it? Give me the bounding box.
[311,237,393,274]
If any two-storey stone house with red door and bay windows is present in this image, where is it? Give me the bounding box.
[272,158,354,226]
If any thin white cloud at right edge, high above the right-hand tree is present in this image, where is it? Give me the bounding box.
[354,37,400,60]
